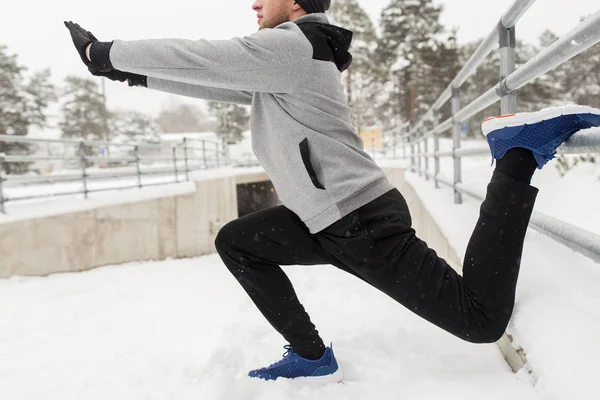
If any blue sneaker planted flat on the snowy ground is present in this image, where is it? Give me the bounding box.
[248,345,343,383]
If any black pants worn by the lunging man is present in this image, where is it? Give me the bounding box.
[215,172,538,358]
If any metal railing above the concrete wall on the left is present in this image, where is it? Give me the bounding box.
[0,135,229,213]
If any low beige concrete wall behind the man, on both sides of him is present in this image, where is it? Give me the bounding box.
[0,168,461,278]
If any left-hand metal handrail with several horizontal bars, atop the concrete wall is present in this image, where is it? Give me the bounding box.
[0,135,230,213]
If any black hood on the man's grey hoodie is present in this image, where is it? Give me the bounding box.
[293,13,354,72]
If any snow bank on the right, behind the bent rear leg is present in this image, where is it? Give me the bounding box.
[388,143,600,399]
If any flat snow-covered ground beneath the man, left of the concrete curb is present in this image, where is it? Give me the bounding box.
[0,255,540,400]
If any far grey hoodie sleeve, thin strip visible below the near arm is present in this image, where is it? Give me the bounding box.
[148,76,253,105]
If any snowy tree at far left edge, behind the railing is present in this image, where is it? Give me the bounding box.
[0,45,56,173]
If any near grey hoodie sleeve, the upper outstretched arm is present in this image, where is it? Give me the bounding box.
[107,22,313,93]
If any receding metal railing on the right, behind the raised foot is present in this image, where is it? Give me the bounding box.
[384,0,600,262]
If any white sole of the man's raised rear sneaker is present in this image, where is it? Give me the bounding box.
[481,105,600,136]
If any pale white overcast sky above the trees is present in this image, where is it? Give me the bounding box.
[0,0,600,114]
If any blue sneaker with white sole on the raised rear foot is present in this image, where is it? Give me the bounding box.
[481,105,600,169]
